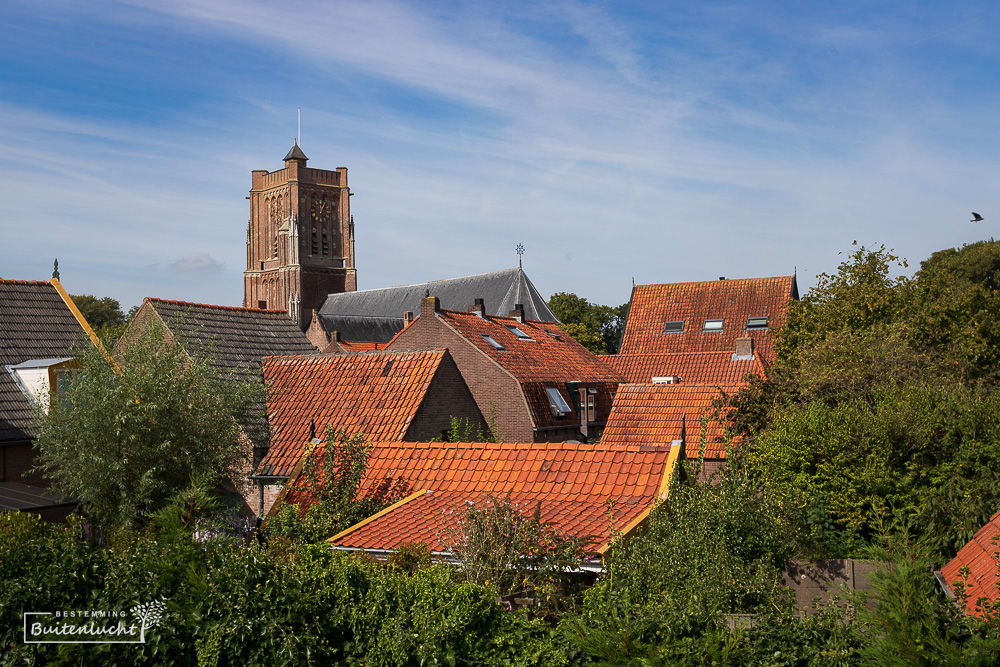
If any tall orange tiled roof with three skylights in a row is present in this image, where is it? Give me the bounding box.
[620,276,798,360]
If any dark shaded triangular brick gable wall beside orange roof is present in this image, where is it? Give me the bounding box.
[403,353,487,442]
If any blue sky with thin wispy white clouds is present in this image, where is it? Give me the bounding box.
[0,0,1000,308]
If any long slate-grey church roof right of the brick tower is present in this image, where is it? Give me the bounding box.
[319,268,558,343]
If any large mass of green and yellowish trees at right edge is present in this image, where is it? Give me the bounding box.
[731,241,1000,557]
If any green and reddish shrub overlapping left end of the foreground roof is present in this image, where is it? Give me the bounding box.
[267,427,405,542]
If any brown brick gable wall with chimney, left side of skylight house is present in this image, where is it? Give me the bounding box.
[386,297,534,442]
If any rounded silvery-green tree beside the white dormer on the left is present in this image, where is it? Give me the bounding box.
[35,323,263,529]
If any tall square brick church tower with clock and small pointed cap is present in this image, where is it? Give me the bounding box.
[243,143,357,329]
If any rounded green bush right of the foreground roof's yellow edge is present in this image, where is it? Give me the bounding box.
[606,469,798,615]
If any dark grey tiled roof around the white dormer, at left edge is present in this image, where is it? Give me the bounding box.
[0,280,85,443]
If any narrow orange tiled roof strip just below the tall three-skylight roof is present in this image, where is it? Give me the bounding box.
[601,351,765,387]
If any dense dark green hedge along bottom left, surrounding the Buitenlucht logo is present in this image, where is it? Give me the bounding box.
[0,512,574,667]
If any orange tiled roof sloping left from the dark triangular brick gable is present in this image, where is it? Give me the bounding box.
[257,349,447,477]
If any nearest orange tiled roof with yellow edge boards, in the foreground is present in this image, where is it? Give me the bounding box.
[296,442,677,551]
